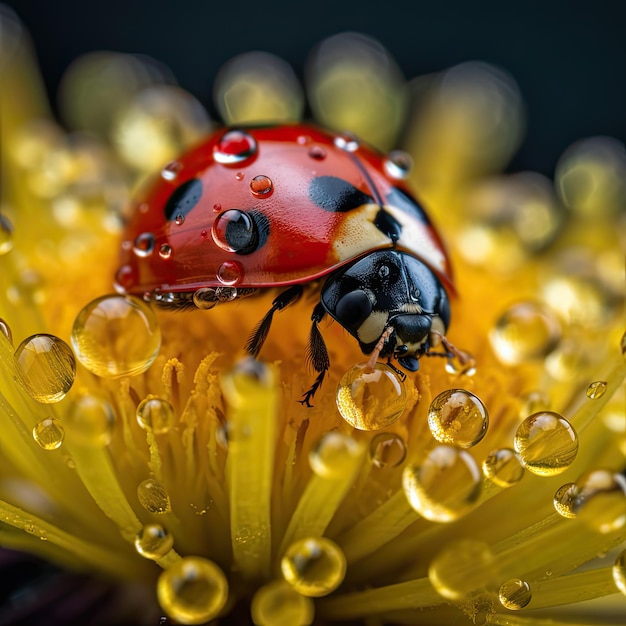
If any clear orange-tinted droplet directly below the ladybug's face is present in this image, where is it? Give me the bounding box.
[337,363,406,430]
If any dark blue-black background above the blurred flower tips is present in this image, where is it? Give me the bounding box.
[5,0,626,175]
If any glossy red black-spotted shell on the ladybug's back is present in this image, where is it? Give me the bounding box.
[116,125,451,293]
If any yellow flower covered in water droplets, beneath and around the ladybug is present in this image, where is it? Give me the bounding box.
[0,16,626,626]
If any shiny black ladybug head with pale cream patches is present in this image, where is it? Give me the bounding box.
[321,250,450,371]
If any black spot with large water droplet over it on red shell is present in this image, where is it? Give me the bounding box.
[211,209,269,254]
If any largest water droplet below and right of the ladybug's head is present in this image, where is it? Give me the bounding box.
[402,446,481,522]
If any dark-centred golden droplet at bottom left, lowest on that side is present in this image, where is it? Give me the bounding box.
[157,556,228,624]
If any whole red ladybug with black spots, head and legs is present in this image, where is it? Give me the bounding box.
[115,124,454,406]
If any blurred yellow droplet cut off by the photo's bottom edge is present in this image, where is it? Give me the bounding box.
[250,580,315,626]
